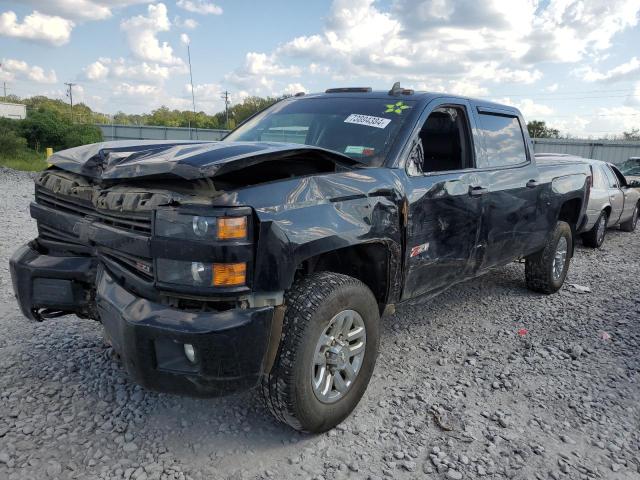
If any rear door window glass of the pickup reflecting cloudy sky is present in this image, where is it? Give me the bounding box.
[480,113,527,167]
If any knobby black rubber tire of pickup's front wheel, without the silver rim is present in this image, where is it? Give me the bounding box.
[261,272,380,433]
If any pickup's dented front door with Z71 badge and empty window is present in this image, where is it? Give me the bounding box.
[403,99,488,299]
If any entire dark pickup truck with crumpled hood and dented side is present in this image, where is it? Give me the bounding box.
[11,85,591,432]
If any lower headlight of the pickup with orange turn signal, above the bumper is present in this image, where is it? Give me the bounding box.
[156,258,247,287]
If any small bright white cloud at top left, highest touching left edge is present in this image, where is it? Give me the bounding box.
[0,11,74,46]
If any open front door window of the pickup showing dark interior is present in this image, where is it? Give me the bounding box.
[408,106,473,175]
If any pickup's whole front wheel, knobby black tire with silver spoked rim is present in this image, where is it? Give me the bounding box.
[261,272,380,433]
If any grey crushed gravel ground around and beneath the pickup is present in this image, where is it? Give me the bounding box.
[0,166,640,480]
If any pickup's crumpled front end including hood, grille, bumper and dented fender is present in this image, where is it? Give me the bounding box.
[10,139,397,396]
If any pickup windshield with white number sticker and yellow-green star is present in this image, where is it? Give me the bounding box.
[224,97,415,166]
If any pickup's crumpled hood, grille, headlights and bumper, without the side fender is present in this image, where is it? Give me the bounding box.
[10,144,358,395]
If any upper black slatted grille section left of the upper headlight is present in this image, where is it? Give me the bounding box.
[36,186,151,235]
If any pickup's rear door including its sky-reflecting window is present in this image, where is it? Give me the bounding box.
[475,106,548,268]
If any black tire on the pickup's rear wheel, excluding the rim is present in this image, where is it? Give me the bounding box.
[524,221,573,294]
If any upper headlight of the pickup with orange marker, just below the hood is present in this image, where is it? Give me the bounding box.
[155,210,247,240]
